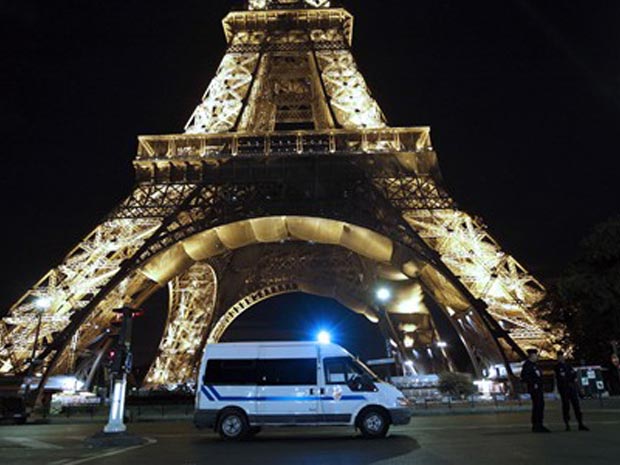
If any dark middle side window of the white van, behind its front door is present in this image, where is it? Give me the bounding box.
[258,358,317,386]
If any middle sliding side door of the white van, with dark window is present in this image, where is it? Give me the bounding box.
[256,345,320,424]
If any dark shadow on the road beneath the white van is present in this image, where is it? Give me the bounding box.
[196,434,420,465]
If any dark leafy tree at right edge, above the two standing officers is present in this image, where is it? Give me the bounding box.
[541,216,620,363]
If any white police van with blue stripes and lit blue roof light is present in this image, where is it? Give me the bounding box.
[194,342,411,439]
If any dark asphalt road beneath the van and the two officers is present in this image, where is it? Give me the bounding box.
[0,409,620,465]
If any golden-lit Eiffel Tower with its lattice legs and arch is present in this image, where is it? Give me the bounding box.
[0,0,553,386]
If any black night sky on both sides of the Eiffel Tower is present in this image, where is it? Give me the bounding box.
[0,0,620,356]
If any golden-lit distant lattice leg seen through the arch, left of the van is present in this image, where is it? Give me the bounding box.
[146,262,217,386]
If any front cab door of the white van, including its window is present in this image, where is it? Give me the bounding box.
[321,357,377,423]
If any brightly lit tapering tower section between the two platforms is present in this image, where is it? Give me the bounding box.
[185,5,386,134]
